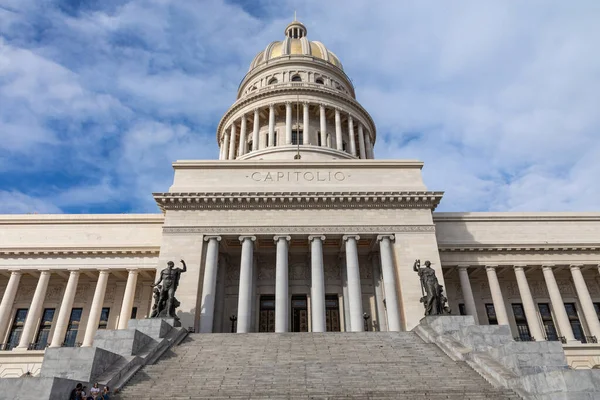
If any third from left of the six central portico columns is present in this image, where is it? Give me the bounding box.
[274,235,291,332]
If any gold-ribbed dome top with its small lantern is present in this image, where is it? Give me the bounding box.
[250,21,343,70]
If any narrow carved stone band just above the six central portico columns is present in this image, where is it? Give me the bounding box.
[163,225,435,235]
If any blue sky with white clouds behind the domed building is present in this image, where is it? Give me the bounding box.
[0,0,600,214]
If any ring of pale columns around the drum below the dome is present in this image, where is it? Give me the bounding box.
[219,101,374,160]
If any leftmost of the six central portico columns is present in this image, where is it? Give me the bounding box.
[200,236,221,333]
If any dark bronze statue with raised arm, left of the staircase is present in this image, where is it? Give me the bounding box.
[150,260,187,320]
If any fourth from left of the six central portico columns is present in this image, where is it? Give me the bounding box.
[308,235,326,332]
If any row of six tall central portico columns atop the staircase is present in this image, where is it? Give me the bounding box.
[200,234,400,333]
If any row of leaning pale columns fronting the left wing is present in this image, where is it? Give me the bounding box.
[0,268,139,350]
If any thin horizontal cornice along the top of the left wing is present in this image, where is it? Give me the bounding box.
[0,246,160,257]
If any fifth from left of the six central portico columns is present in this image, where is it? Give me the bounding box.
[342,235,364,332]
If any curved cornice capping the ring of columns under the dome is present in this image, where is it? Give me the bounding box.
[217,82,377,143]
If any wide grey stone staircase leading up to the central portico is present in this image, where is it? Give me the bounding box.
[116,332,520,400]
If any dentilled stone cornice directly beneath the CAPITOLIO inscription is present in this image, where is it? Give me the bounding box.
[153,191,443,211]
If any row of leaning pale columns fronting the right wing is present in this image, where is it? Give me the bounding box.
[458,265,600,343]
